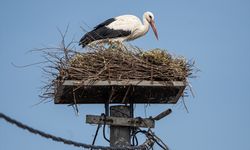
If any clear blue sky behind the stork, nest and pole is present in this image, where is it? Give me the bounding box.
[0,0,250,150]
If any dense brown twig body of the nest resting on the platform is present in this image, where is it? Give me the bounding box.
[58,42,193,81]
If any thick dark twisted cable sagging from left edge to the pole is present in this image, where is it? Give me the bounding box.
[0,113,154,150]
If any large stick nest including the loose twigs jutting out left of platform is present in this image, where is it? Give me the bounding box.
[39,40,194,98]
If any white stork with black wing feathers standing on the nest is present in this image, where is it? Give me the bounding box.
[79,12,158,47]
